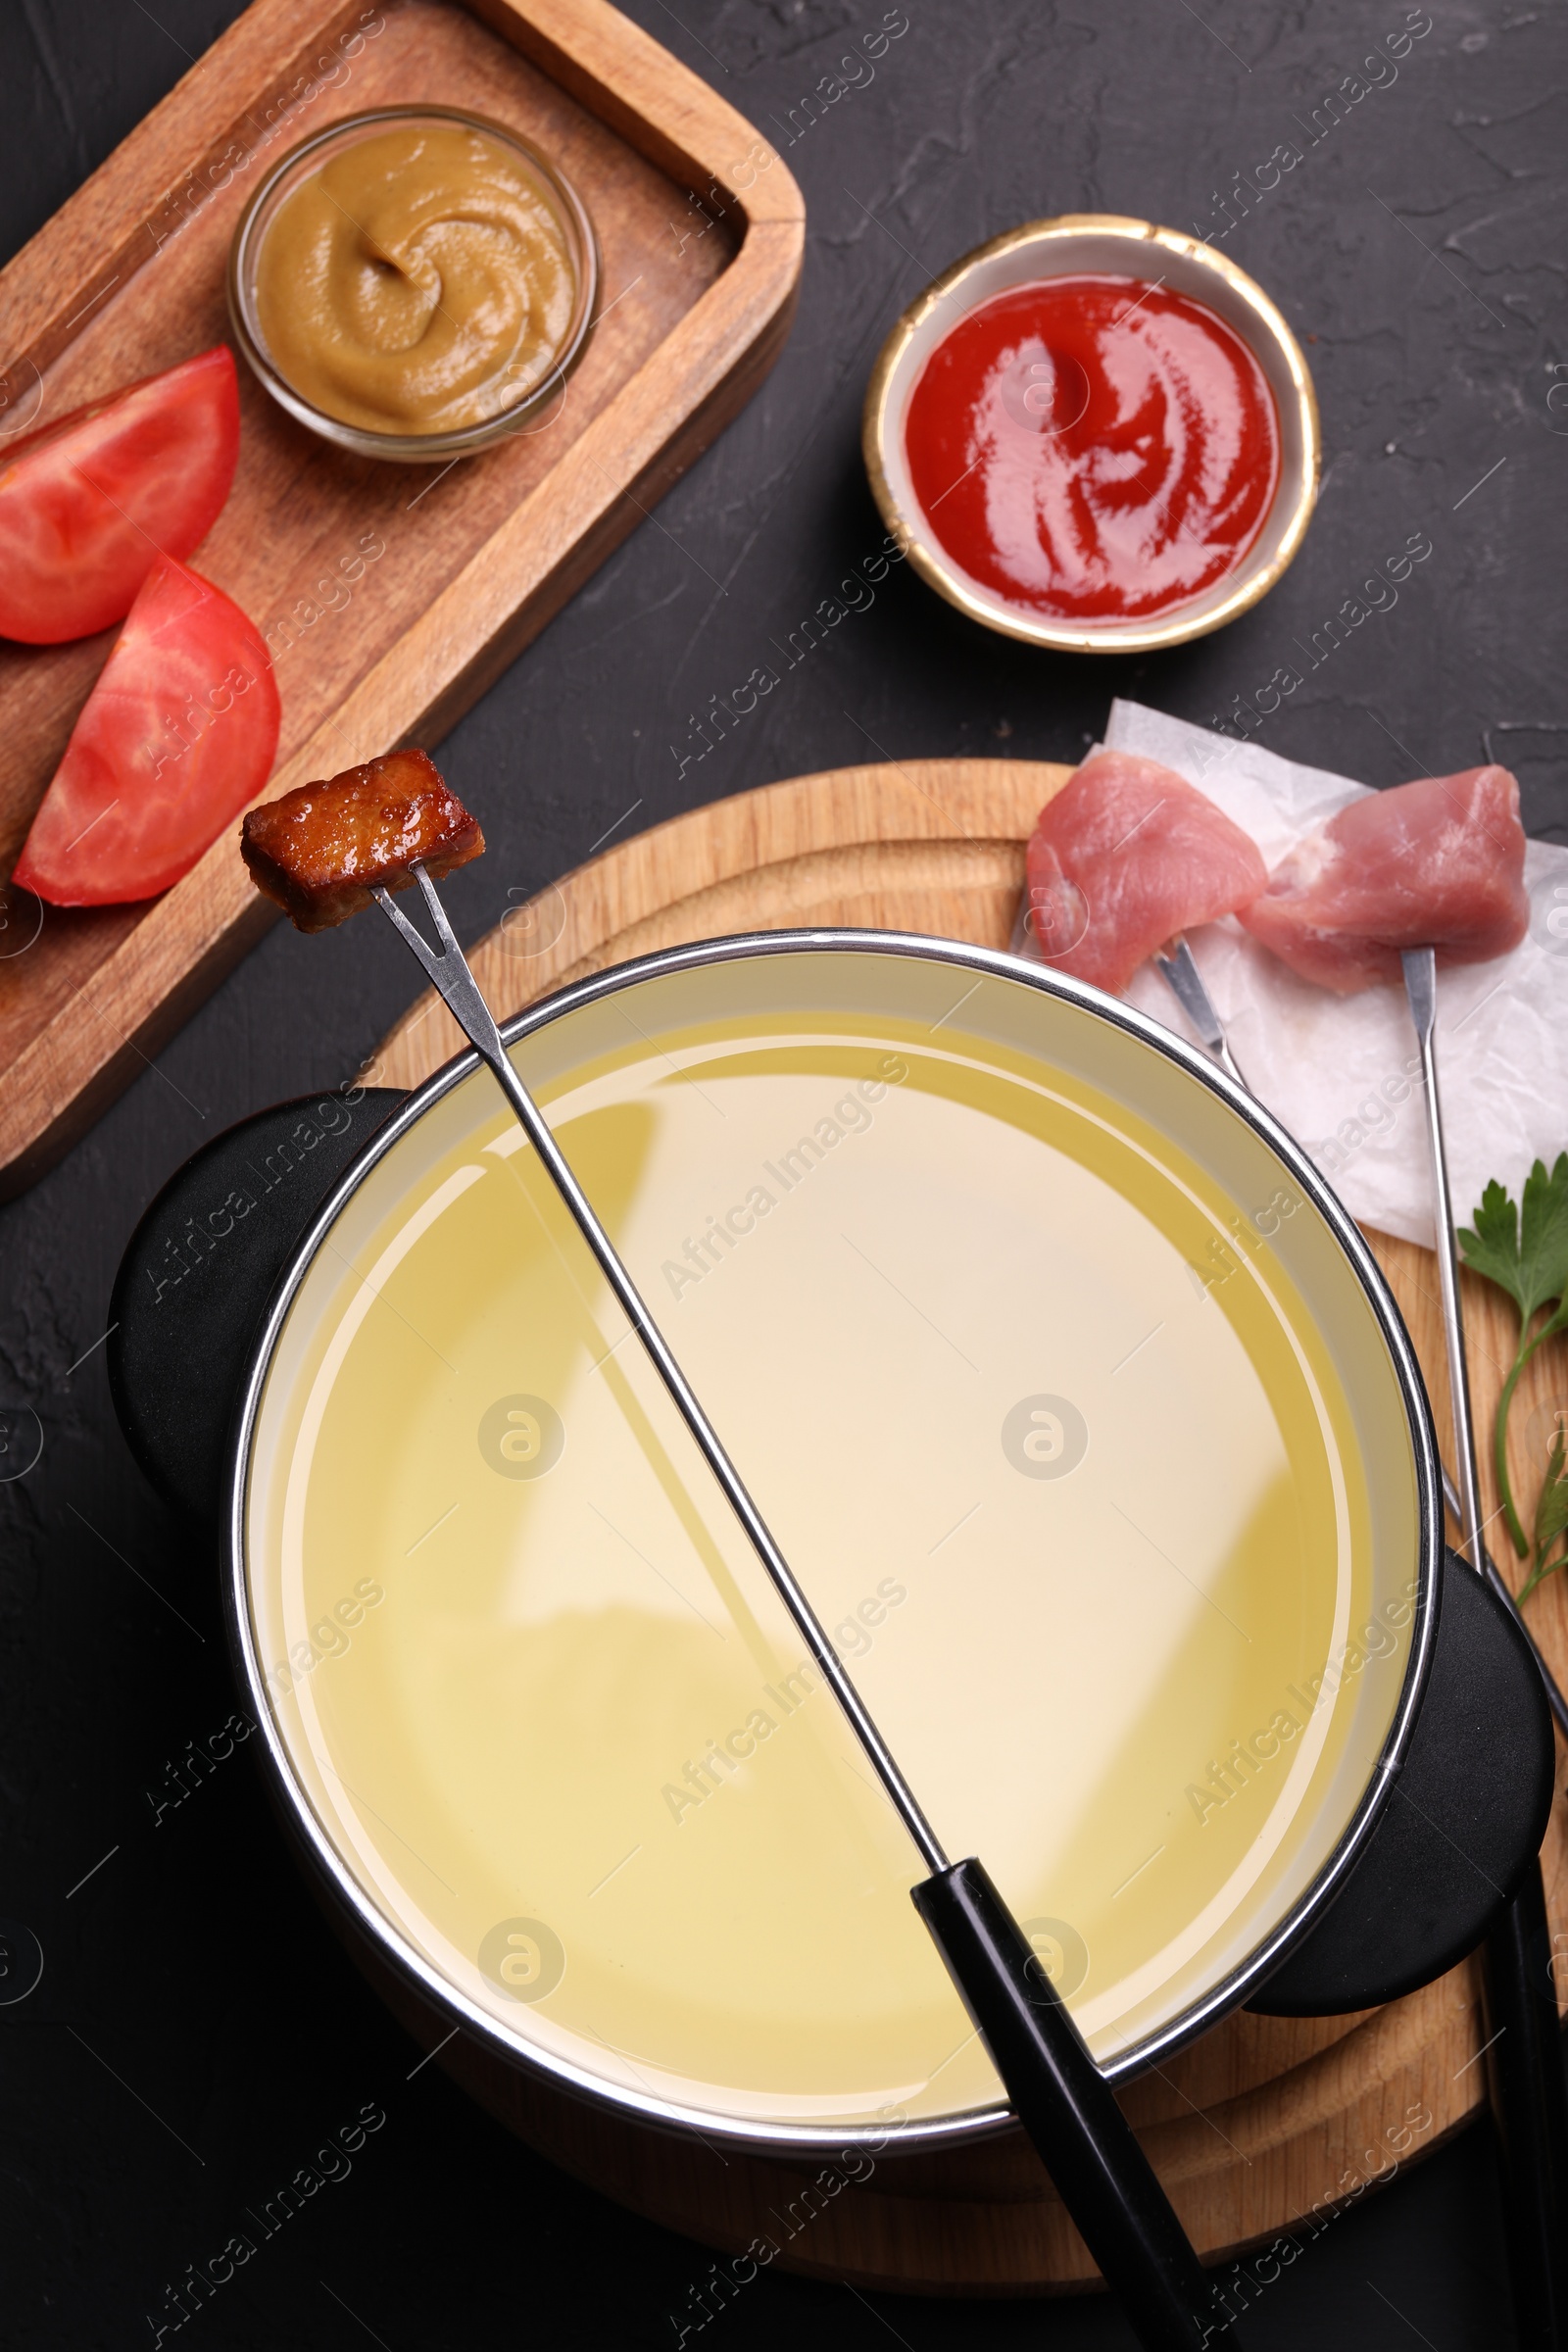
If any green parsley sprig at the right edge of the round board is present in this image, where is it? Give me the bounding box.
[1460,1152,1568,1599]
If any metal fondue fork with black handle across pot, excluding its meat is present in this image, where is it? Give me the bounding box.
[373,860,1237,2352]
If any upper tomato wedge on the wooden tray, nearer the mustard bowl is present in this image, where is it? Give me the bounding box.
[0,343,240,645]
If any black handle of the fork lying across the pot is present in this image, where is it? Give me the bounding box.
[909,1858,1237,2352]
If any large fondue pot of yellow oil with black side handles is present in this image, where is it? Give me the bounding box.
[111,931,1551,2244]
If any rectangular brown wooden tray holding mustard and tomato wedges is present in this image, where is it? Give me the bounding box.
[0,0,804,1193]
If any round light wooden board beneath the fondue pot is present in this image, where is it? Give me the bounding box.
[376,760,1568,2295]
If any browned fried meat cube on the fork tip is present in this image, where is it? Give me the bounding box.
[240,751,484,931]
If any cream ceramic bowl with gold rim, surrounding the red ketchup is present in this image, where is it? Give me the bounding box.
[862,212,1321,654]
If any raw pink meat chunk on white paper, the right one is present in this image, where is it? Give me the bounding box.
[1242,766,1531,998]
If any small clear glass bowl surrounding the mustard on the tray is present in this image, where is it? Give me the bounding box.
[228,106,600,466]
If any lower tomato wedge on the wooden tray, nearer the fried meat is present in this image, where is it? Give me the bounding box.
[14,555,277,906]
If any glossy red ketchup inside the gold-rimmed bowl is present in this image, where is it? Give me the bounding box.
[906,275,1279,623]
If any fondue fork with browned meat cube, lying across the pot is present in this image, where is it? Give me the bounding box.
[242,753,1262,2352]
